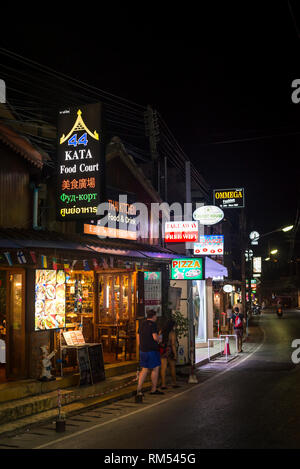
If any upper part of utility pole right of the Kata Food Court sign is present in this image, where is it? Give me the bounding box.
[144,104,161,194]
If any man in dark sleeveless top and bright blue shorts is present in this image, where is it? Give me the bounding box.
[137,310,164,395]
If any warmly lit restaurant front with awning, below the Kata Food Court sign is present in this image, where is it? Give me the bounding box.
[0,229,176,381]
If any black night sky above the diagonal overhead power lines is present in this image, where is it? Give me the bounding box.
[1,0,300,232]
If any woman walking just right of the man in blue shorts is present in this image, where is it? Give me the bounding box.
[160,319,179,389]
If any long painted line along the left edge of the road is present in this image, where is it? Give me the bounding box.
[33,329,265,449]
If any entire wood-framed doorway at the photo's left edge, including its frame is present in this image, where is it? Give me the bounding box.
[0,269,25,382]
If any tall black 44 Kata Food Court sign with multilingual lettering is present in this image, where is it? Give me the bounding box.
[57,103,104,221]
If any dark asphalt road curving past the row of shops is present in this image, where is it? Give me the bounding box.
[3,310,300,455]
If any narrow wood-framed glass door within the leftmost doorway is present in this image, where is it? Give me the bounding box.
[6,271,25,378]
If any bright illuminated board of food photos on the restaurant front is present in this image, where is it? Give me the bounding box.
[35,269,66,331]
